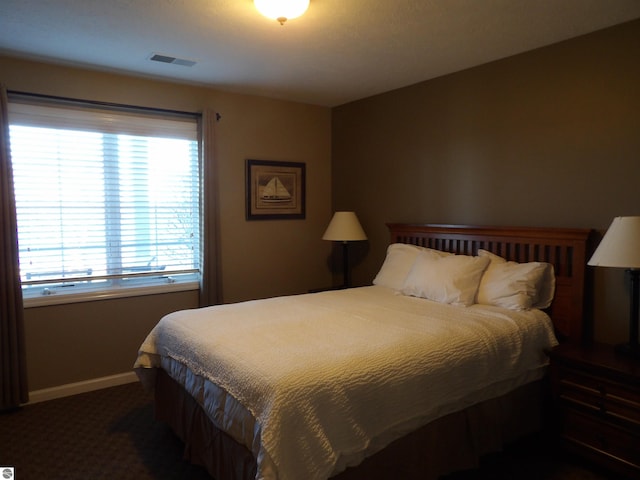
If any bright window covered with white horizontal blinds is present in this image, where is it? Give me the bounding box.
[9,97,201,305]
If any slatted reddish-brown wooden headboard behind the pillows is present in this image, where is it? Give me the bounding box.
[387,223,593,342]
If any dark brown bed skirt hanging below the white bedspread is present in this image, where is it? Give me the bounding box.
[154,369,546,480]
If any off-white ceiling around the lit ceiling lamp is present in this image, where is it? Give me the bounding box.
[0,0,640,106]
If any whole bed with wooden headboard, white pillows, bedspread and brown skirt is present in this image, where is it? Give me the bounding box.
[134,224,590,480]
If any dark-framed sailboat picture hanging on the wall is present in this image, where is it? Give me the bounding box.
[246,160,305,220]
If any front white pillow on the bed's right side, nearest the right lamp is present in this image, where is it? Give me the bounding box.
[478,250,555,310]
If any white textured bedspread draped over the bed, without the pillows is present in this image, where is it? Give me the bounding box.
[135,286,556,480]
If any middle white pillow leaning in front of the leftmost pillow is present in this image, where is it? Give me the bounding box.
[402,251,490,306]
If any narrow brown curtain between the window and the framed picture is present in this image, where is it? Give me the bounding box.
[200,110,222,307]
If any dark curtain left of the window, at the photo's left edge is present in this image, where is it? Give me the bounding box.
[0,85,29,410]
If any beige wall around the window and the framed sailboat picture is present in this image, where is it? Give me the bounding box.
[0,56,331,390]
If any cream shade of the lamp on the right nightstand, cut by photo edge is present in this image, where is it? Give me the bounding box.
[588,216,640,269]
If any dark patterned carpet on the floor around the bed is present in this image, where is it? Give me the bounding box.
[0,383,613,480]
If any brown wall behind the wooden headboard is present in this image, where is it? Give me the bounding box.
[332,21,640,343]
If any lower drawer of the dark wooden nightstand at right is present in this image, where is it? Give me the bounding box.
[561,409,640,473]
